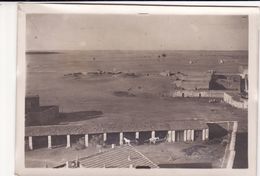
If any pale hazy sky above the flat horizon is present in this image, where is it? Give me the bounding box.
[26,14,248,51]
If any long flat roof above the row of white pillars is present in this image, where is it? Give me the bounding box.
[25,120,208,136]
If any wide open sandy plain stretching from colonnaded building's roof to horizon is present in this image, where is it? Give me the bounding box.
[26,51,247,131]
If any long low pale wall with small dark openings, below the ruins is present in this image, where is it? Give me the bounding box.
[172,90,224,98]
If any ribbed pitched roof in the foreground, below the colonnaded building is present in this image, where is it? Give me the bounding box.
[79,145,158,168]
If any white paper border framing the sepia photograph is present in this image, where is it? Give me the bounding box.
[15,4,260,176]
